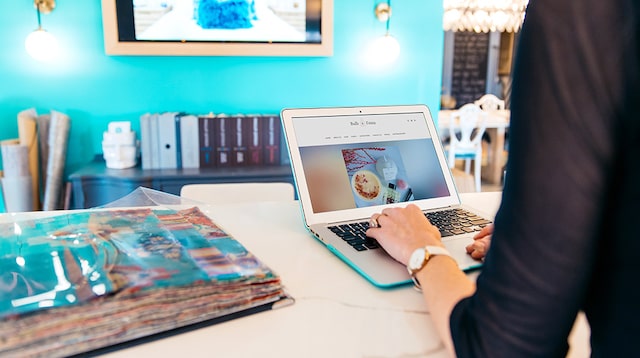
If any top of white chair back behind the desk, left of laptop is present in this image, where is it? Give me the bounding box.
[180,182,295,204]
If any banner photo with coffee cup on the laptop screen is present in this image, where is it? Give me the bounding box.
[300,138,449,213]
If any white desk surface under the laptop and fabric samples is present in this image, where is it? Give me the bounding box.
[92,193,589,358]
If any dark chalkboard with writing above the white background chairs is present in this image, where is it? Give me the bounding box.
[451,31,489,108]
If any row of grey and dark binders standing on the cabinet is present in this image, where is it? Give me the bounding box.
[140,112,281,169]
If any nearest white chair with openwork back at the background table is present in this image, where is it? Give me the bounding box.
[448,103,487,192]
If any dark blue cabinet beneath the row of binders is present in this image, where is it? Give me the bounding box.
[69,160,293,209]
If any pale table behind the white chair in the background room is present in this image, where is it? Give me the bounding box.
[438,109,511,184]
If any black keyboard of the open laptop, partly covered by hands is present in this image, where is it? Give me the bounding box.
[329,208,491,251]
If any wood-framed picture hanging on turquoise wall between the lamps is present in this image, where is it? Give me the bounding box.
[102,0,333,56]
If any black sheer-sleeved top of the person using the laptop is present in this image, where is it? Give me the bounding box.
[451,0,640,357]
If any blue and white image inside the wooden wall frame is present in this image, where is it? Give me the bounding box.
[131,0,309,43]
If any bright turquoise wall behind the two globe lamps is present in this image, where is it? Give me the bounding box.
[0,0,444,172]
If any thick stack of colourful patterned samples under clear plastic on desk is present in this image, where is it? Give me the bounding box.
[0,189,292,357]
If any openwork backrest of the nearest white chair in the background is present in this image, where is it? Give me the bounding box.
[449,103,487,150]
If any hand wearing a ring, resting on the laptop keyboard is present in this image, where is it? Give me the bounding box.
[367,204,442,265]
